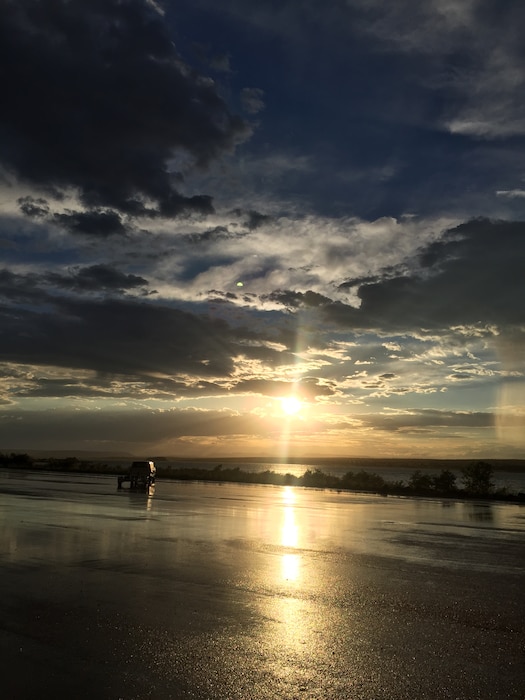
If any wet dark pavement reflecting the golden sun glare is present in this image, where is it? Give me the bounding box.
[0,471,525,700]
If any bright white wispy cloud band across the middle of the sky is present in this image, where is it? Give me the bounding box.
[141,213,455,304]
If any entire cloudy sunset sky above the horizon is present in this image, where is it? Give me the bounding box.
[0,0,525,461]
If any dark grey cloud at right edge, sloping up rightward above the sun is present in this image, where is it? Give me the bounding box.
[325,219,525,331]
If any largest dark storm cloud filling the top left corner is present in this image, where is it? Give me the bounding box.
[0,0,249,215]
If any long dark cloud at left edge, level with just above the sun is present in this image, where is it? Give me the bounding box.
[0,298,279,377]
